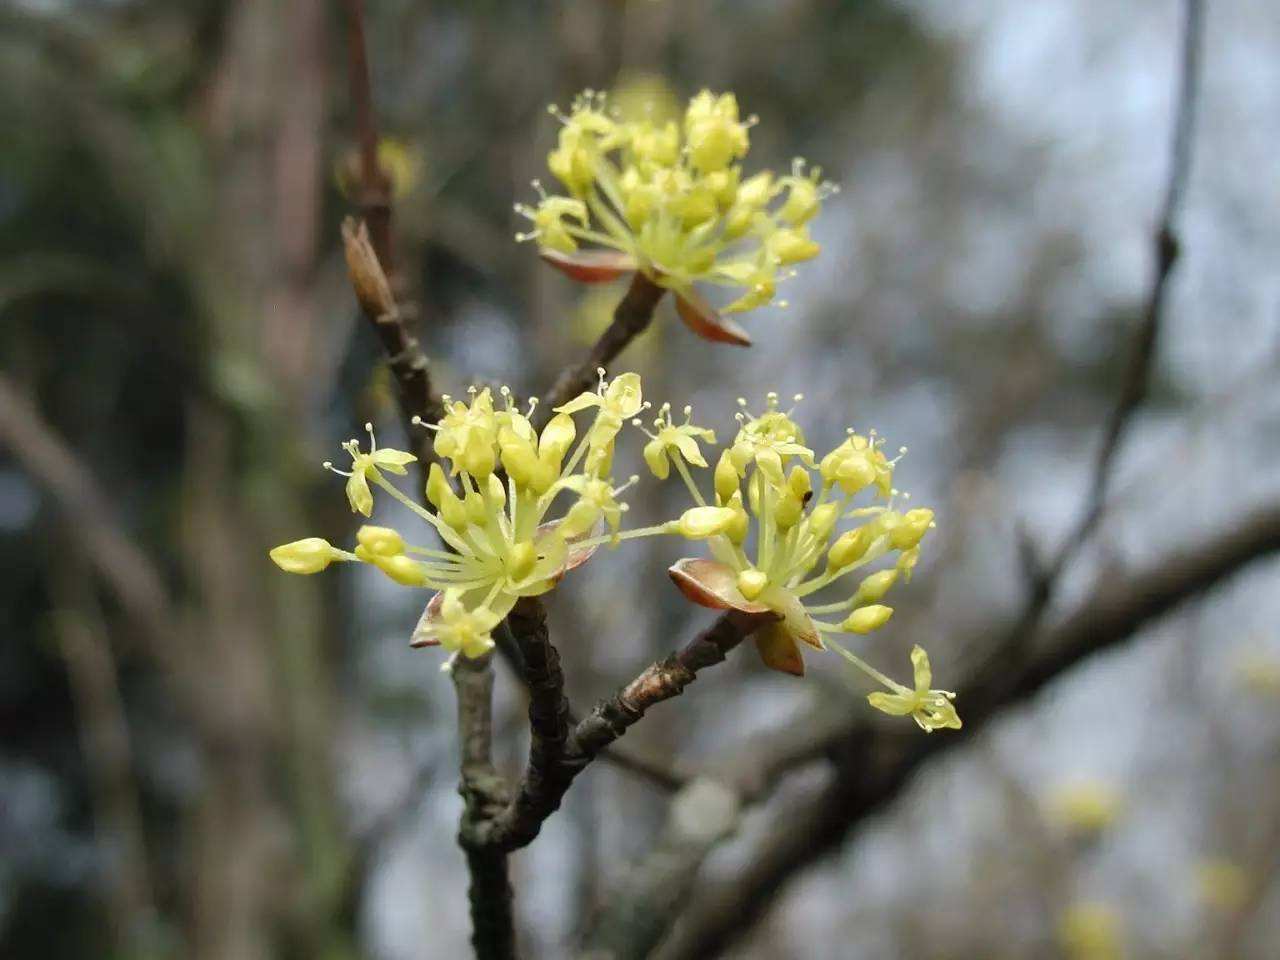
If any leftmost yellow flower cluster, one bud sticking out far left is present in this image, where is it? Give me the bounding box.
[271,371,645,657]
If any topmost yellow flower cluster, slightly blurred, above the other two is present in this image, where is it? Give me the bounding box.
[516,90,836,339]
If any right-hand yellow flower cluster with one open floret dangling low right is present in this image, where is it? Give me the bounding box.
[645,393,960,731]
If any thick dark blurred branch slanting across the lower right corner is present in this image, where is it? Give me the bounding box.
[659,507,1280,960]
